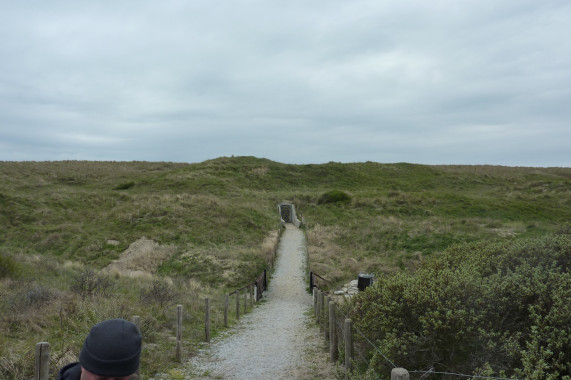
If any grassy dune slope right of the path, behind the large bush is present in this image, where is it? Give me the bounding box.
[297,163,571,285]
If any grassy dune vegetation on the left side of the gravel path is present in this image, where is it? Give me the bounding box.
[0,160,279,379]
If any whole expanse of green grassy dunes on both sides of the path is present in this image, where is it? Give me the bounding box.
[0,157,571,378]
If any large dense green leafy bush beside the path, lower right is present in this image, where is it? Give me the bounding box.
[352,234,571,379]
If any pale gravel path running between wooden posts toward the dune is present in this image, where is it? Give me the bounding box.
[187,224,335,379]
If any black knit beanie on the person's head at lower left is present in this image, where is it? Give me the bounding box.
[79,319,142,377]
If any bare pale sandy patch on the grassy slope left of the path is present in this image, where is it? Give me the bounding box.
[104,237,176,277]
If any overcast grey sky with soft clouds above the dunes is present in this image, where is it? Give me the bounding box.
[0,0,571,167]
